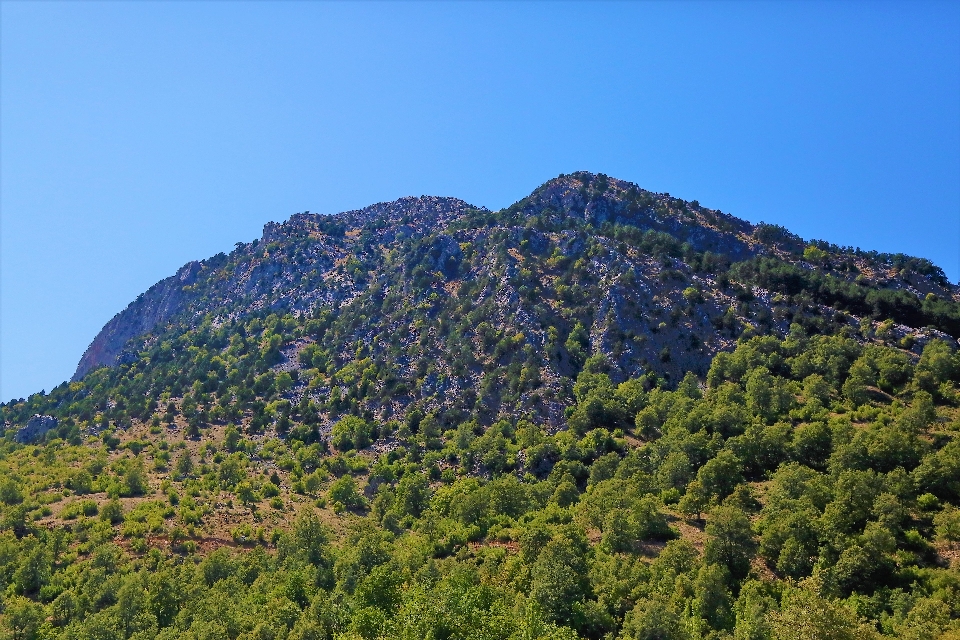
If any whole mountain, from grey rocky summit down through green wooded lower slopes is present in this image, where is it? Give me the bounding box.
[0,172,960,640]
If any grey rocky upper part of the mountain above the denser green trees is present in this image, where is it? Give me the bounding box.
[73,172,960,426]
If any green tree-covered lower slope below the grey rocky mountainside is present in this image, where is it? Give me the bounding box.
[0,328,960,640]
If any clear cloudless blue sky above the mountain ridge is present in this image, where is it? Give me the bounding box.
[0,2,960,400]
